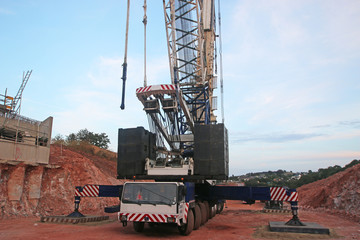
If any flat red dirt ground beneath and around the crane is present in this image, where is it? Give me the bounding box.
[0,201,360,240]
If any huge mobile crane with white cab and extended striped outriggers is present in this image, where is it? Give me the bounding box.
[69,0,301,235]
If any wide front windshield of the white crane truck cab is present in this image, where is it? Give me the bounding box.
[122,183,177,205]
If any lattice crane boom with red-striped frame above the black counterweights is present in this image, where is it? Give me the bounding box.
[136,0,216,158]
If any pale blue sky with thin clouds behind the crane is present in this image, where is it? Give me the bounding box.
[0,0,360,175]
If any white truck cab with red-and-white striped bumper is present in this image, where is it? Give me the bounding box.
[118,182,189,232]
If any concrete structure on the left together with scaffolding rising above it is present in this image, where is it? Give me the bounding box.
[0,70,53,164]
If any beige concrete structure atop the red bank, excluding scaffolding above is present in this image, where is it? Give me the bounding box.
[0,111,53,165]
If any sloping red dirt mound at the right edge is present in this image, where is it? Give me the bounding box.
[297,164,360,221]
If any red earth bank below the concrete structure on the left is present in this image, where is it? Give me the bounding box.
[0,145,122,218]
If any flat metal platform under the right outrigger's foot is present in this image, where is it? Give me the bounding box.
[269,222,330,234]
